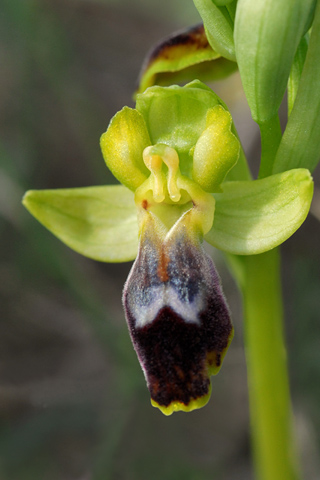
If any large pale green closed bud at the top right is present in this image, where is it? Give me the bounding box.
[234,0,314,123]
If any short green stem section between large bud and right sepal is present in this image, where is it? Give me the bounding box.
[259,114,282,178]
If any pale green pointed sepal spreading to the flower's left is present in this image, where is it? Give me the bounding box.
[23,185,138,262]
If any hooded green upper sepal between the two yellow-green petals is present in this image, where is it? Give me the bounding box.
[136,80,221,175]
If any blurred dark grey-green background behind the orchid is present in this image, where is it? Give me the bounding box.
[0,0,320,480]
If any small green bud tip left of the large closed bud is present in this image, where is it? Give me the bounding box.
[193,0,236,61]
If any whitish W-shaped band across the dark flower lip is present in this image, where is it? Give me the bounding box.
[131,285,203,328]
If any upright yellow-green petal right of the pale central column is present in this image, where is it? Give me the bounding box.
[192,105,240,192]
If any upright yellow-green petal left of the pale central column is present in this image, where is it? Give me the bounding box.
[100,107,151,191]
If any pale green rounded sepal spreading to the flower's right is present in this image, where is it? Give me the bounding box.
[205,169,313,255]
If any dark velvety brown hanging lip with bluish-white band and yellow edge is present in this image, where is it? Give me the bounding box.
[123,214,233,414]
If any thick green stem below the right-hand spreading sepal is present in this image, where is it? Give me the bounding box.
[242,249,299,480]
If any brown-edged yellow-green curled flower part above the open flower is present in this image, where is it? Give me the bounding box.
[136,24,237,94]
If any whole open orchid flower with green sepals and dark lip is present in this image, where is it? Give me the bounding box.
[24,81,313,415]
